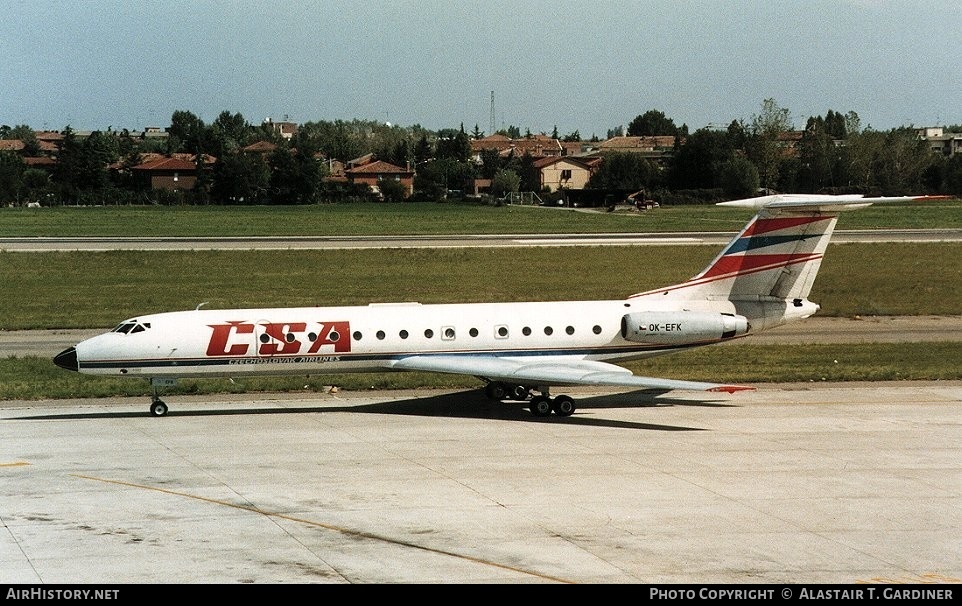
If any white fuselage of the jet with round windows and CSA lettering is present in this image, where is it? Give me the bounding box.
[76,297,764,377]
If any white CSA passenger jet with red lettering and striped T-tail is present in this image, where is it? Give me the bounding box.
[54,194,932,416]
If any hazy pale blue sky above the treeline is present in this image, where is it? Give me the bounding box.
[0,0,962,139]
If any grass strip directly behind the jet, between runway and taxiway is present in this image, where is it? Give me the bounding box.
[0,243,962,330]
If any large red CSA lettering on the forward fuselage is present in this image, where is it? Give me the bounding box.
[207,321,351,356]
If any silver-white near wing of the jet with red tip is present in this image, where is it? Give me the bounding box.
[391,354,754,393]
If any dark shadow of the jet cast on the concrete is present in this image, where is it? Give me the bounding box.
[11,390,737,431]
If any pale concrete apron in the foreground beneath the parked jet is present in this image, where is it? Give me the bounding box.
[0,382,962,584]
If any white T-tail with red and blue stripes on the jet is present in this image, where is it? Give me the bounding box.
[633,194,933,301]
